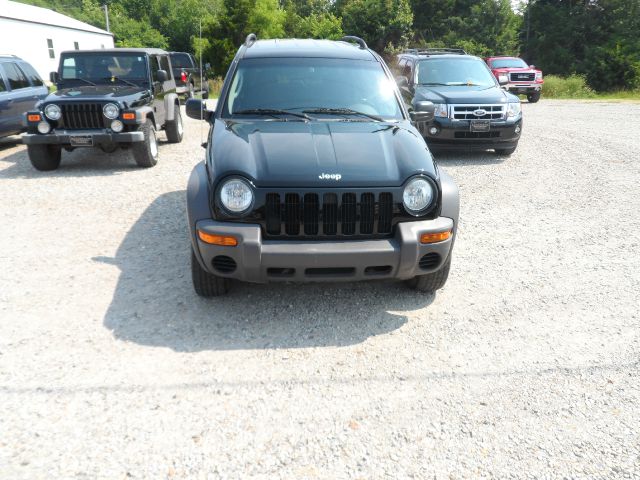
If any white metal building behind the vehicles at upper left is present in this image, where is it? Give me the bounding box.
[0,0,113,82]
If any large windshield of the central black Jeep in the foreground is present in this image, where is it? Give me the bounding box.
[223,58,402,121]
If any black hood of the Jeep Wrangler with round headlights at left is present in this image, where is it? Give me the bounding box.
[42,85,151,108]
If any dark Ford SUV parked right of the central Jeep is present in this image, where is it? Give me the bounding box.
[395,48,522,155]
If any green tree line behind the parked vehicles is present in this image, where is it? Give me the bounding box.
[21,0,640,91]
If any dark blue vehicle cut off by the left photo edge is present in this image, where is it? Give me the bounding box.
[0,55,49,137]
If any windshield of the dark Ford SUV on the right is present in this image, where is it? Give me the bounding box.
[416,58,496,88]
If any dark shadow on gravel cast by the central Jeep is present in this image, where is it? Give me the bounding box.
[101,191,434,352]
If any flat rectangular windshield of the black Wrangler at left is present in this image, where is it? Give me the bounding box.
[60,53,149,85]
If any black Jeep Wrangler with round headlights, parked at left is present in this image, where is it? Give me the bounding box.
[22,48,183,170]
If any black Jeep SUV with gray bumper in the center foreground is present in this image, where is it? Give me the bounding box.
[182,35,459,296]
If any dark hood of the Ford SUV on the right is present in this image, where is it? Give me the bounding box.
[414,85,519,105]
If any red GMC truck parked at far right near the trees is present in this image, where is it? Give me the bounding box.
[484,57,544,103]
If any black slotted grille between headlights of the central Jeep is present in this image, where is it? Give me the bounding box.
[265,192,393,237]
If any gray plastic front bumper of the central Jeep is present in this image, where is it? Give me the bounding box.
[193,217,455,283]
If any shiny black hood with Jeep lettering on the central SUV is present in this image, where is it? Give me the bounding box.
[210,119,436,188]
